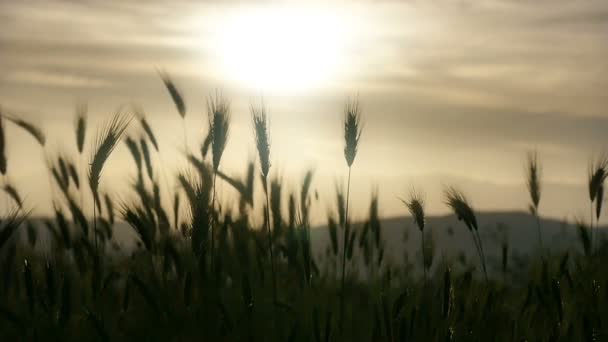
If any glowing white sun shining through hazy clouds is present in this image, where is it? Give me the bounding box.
[214,7,349,92]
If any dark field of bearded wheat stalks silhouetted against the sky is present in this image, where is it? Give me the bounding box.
[0,73,608,341]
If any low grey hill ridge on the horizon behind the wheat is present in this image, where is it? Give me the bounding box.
[20,211,605,263]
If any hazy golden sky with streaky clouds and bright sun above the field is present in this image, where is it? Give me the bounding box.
[0,0,608,221]
